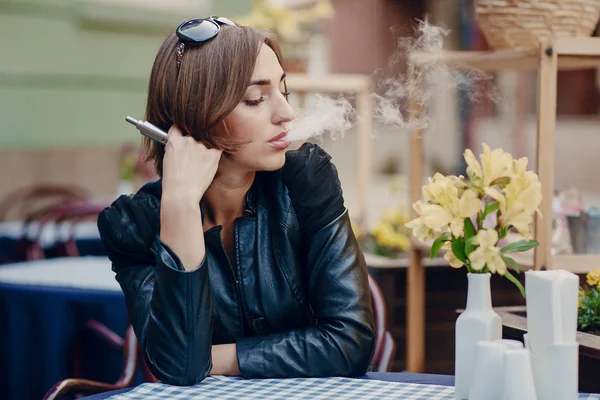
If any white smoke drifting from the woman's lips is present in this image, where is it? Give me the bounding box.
[288,20,499,141]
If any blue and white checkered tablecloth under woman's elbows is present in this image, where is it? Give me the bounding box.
[110,377,600,400]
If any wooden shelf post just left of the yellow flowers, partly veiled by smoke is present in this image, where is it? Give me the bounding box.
[406,65,425,373]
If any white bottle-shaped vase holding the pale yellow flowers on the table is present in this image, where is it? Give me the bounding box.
[454,273,502,400]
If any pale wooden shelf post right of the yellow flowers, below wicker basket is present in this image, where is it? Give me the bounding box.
[534,40,558,270]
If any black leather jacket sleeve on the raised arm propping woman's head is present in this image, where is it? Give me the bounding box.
[98,196,212,385]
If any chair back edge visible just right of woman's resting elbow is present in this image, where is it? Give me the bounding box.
[369,275,396,372]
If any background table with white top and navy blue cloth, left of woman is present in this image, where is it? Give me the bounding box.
[0,257,128,400]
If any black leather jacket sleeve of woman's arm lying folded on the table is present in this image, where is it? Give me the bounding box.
[237,144,374,378]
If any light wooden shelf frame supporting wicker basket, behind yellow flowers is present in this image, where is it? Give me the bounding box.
[406,37,600,372]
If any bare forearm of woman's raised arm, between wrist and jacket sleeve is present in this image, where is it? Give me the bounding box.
[160,193,206,271]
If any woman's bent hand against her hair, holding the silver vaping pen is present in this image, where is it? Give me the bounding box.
[162,125,222,204]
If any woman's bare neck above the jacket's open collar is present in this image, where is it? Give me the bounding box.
[201,162,255,225]
